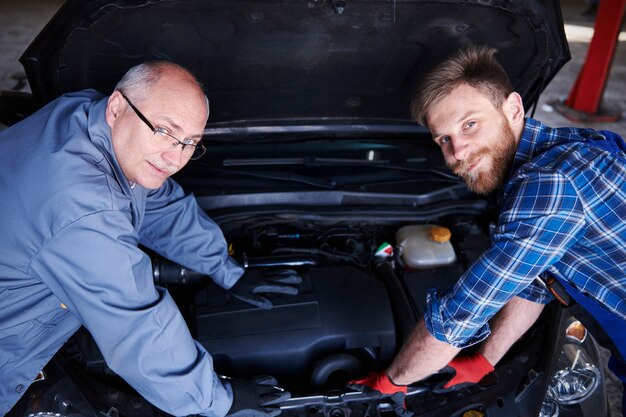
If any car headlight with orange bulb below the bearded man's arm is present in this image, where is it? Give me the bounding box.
[539,321,602,417]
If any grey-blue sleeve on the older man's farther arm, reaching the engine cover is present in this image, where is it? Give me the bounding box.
[140,179,244,288]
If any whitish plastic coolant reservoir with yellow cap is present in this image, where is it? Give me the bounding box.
[396,224,456,268]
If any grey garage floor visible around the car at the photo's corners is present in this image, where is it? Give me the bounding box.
[0,0,626,417]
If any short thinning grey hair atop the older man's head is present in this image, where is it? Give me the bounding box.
[115,61,209,114]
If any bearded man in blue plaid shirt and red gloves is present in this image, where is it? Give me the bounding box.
[350,47,626,412]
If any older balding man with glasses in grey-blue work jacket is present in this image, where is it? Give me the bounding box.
[0,62,288,417]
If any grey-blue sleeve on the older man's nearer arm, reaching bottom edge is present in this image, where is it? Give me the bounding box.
[30,211,232,417]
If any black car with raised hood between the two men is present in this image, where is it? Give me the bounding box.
[0,0,607,417]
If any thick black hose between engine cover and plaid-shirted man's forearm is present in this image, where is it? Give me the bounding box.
[375,261,417,346]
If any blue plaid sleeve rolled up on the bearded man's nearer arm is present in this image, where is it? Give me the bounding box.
[425,172,585,348]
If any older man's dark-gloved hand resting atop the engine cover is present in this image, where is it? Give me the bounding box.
[230,269,302,310]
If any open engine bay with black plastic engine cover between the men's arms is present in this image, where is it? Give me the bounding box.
[166,217,489,390]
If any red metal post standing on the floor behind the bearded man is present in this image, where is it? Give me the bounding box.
[564,0,626,121]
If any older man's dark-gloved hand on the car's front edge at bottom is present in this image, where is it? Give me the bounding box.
[225,376,291,417]
